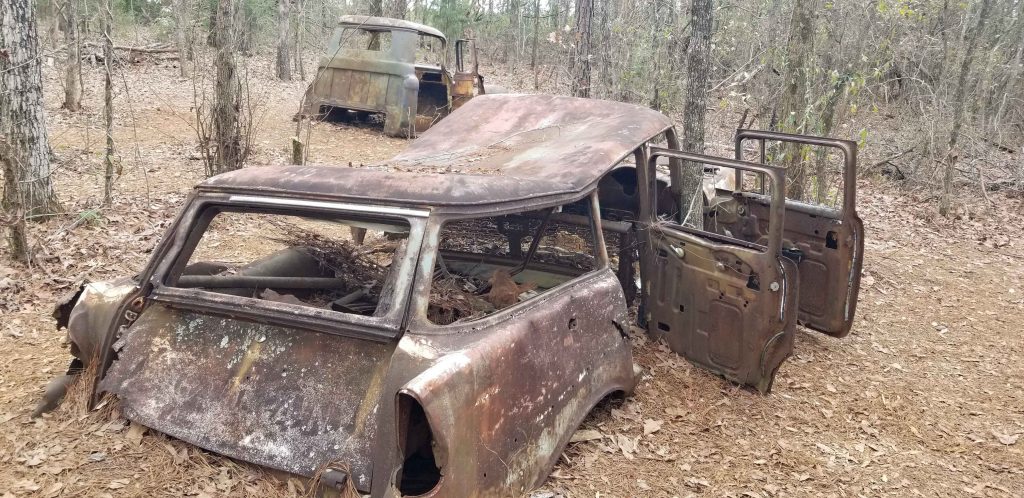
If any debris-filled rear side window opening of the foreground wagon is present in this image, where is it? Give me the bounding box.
[427,200,611,325]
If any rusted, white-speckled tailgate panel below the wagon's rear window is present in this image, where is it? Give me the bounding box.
[100,305,394,490]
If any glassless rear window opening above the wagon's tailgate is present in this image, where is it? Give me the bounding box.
[165,207,410,317]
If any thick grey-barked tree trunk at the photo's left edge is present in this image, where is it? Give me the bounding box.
[0,0,57,217]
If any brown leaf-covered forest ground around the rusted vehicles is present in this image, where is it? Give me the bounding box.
[0,54,1024,498]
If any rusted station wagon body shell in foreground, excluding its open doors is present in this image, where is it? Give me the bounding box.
[72,95,671,496]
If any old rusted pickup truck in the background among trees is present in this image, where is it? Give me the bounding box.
[301,15,493,136]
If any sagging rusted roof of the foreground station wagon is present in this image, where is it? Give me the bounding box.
[199,94,672,211]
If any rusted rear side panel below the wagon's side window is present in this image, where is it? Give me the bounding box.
[366,266,638,497]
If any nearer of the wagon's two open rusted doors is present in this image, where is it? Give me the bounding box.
[639,148,798,392]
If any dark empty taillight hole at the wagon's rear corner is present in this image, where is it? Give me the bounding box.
[398,393,441,496]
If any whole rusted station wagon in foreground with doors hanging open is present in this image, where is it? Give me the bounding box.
[44,95,863,496]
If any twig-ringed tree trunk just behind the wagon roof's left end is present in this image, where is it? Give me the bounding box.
[207,0,242,176]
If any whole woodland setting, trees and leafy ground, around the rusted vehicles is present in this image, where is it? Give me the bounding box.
[0,0,1024,498]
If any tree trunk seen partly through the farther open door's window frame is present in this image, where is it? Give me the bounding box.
[779,0,819,199]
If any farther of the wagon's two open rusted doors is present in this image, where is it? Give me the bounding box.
[735,129,864,337]
